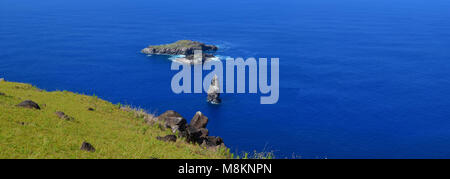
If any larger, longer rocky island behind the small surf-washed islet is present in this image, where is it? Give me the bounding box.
[141,40,218,55]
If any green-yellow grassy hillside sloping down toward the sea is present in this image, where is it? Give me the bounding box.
[0,82,230,159]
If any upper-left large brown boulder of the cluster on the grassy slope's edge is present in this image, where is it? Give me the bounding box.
[156,110,187,133]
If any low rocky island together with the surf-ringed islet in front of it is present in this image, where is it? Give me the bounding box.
[141,40,219,64]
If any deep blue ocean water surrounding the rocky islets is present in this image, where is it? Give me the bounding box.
[0,0,450,158]
